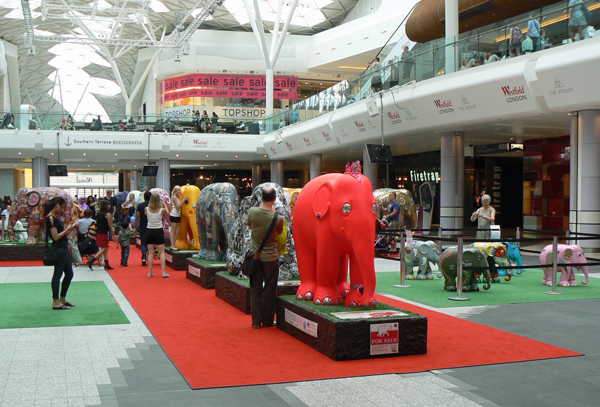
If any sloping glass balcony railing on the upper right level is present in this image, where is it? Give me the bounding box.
[265,0,600,133]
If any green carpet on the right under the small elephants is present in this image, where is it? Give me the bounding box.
[377,269,600,308]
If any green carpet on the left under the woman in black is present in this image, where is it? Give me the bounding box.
[0,281,129,329]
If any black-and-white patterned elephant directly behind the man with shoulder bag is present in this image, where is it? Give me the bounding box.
[227,182,298,281]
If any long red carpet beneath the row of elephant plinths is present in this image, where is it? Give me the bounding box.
[104,248,581,388]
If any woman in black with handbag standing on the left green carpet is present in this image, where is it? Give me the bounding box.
[44,196,77,310]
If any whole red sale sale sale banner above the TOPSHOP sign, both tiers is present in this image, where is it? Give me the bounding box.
[161,74,298,103]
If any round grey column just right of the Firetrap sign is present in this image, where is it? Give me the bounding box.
[440,131,465,235]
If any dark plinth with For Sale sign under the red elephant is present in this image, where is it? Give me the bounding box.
[277,296,427,360]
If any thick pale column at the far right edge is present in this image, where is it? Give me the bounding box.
[569,110,600,249]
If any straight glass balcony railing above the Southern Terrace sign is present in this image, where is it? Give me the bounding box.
[0,111,264,134]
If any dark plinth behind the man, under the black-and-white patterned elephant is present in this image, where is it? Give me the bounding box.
[215,271,300,315]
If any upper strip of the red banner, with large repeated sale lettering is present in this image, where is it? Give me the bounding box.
[162,74,298,92]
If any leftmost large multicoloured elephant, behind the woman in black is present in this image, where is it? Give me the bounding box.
[8,187,74,243]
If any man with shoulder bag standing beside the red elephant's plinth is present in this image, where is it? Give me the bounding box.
[248,187,283,328]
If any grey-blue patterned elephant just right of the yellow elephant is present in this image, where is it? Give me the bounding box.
[196,182,239,261]
